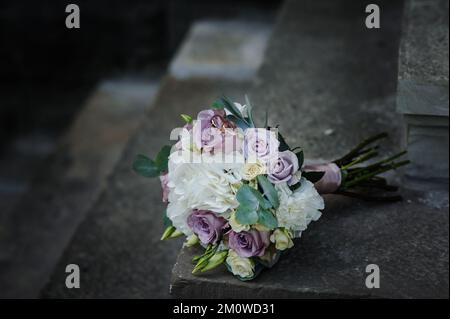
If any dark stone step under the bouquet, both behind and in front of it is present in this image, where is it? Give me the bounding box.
[171,0,449,299]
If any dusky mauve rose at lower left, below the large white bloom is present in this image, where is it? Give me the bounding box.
[187,210,227,245]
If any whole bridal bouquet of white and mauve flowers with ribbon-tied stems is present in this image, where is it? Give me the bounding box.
[133,97,408,280]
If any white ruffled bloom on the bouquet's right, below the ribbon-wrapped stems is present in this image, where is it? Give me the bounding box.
[275,178,325,232]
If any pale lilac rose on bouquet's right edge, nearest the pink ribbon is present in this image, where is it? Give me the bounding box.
[267,151,299,184]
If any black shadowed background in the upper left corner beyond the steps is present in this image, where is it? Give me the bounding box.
[0,0,281,148]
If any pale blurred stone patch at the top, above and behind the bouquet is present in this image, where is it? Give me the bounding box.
[170,20,270,80]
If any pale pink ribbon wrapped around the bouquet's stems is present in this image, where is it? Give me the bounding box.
[303,163,342,194]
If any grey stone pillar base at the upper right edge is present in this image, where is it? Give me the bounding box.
[397,0,449,184]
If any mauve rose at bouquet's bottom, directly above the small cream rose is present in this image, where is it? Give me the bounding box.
[228,229,270,257]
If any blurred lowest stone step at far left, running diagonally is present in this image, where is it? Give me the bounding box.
[0,79,157,298]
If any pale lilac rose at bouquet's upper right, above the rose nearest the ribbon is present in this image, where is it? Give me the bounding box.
[244,128,280,164]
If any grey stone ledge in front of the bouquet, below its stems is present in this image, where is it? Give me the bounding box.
[171,193,449,299]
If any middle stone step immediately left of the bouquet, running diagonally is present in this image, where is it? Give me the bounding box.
[43,18,266,298]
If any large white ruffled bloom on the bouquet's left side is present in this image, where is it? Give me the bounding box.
[167,151,243,235]
